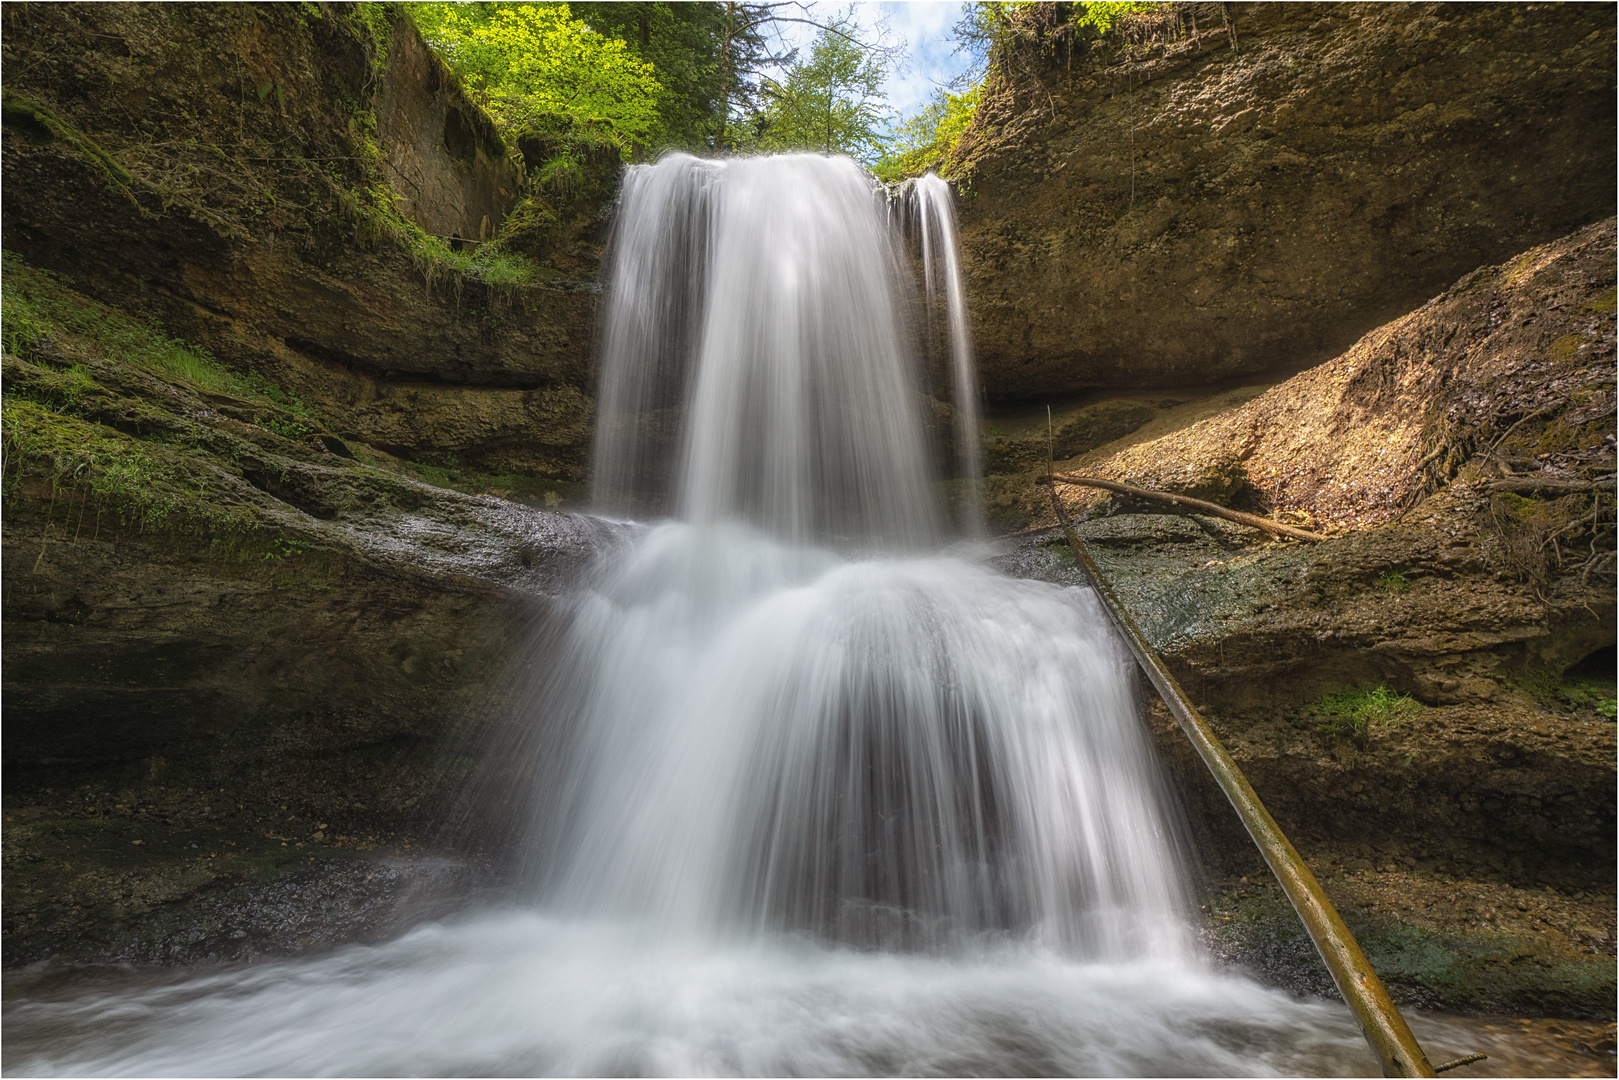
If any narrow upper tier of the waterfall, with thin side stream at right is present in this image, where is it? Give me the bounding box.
[593,154,976,547]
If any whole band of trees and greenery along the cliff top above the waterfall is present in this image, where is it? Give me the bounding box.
[390,0,1183,188]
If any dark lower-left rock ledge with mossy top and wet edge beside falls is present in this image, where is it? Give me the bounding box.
[0,323,622,965]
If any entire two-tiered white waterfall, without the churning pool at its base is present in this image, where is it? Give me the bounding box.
[534,155,1185,957]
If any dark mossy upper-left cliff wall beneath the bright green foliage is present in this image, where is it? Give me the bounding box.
[3,3,608,481]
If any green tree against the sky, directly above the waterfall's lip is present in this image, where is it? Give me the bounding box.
[758,21,887,160]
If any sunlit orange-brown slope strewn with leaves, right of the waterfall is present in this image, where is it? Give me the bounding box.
[1069,219,1616,528]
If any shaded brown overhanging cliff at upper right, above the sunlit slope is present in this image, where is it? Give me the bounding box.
[962,3,1614,398]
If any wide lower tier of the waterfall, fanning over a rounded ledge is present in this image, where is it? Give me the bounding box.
[536,525,1188,959]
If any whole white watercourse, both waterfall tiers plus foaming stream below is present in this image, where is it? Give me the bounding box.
[5,155,1431,1075]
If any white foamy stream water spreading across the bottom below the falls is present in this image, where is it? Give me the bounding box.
[5,912,1376,1077]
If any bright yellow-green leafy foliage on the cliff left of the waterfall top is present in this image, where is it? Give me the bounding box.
[408,3,662,157]
